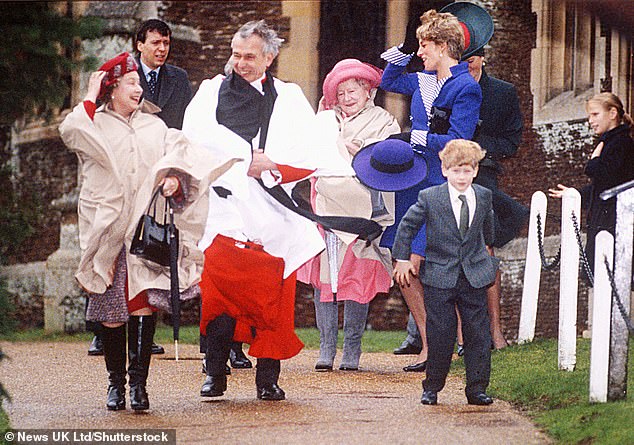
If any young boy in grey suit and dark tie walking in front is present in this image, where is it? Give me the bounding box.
[392,139,498,405]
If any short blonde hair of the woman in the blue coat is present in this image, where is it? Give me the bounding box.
[416,9,465,60]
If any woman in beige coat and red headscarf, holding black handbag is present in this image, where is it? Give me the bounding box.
[60,53,234,411]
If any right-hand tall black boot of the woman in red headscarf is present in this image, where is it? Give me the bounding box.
[128,314,156,411]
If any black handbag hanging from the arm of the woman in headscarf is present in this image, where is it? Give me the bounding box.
[130,187,178,266]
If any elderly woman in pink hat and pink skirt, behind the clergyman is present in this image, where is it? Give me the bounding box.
[298,59,400,371]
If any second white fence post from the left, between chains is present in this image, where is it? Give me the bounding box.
[558,187,581,371]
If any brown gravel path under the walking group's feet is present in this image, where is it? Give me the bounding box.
[0,342,550,445]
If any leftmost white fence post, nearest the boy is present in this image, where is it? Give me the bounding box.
[517,191,547,344]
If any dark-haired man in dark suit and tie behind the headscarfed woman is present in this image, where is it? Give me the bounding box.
[135,19,192,130]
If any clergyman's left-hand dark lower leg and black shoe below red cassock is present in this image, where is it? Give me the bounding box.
[200,314,236,397]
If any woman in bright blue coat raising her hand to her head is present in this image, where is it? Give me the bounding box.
[380,10,478,371]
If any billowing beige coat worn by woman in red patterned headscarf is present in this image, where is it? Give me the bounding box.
[59,101,238,298]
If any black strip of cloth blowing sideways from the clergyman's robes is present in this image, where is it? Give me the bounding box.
[257,179,383,242]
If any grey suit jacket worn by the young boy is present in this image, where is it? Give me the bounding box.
[392,183,499,289]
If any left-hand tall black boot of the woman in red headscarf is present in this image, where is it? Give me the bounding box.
[101,325,126,411]
